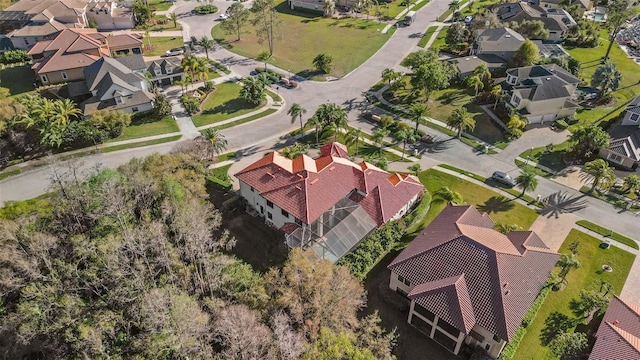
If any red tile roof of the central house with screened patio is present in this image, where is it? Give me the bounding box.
[235,144,424,225]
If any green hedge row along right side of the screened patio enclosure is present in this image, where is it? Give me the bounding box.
[338,221,405,280]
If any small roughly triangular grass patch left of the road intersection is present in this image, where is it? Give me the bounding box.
[191,82,264,127]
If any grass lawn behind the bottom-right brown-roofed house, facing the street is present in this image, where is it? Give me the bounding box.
[408,169,538,234]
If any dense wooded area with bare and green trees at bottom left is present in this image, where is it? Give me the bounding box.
[0,154,395,359]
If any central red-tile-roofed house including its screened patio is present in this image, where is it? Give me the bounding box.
[235,143,424,262]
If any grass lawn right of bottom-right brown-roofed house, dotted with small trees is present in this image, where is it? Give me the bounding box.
[513,229,635,360]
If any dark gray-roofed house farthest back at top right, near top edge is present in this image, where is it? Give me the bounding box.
[492,2,576,41]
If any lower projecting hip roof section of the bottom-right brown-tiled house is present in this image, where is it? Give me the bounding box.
[408,275,476,334]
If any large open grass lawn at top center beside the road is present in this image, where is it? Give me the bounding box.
[211,2,391,77]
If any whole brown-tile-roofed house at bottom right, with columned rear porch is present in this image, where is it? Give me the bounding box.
[388,205,559,358]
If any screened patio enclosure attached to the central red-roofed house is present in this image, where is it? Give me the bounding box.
[286,197,377,263]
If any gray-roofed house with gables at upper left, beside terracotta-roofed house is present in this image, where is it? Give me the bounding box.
[80,55,154,115]
